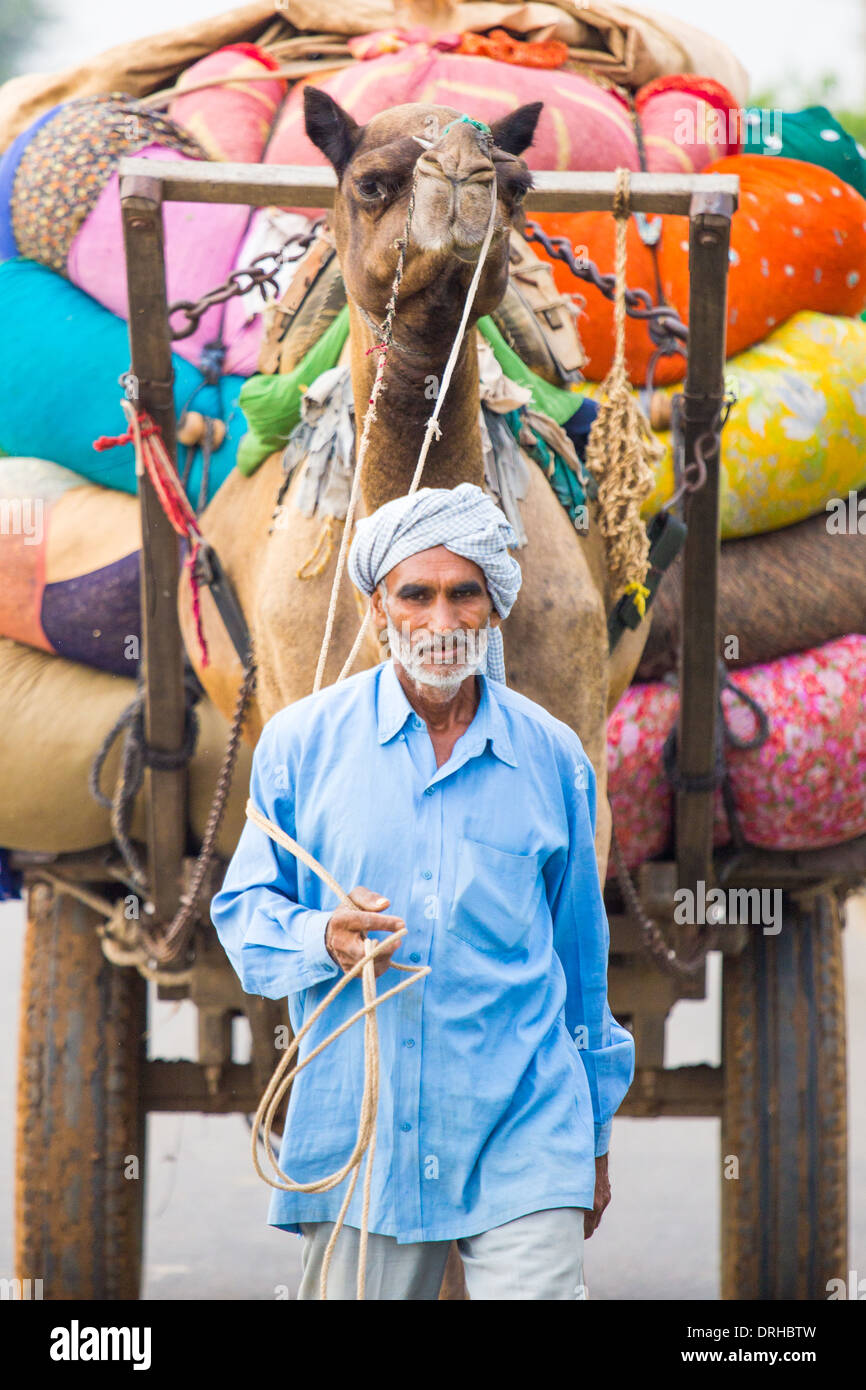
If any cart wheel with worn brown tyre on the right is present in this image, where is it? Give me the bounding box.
[721,891,848,1300]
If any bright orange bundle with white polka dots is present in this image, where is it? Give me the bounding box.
[537,154,866,386]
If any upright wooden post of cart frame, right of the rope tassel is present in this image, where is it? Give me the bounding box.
[676,192,737,891]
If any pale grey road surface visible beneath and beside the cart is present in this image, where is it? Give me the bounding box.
[0,897,866,1300]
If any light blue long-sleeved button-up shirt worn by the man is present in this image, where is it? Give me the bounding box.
[211,660,634,1243]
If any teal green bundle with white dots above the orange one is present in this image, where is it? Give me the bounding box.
[742,106,866,197]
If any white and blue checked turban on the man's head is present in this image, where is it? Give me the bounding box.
[349,482,523,681]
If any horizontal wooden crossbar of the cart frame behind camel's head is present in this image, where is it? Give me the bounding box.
[120,158,740,217]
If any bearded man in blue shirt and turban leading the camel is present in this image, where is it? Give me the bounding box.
[213,484,634,1300]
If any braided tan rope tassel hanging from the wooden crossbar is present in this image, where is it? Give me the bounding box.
[587,168,664,612]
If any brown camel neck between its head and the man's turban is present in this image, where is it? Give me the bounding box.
[350,303,484,514]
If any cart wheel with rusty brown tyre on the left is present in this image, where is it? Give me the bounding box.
[15,884,147,1300]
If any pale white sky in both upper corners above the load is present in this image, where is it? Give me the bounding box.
[11,0,866,107]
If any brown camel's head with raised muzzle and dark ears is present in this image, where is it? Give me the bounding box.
[304,88,542,331]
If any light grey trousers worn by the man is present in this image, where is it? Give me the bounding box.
[297,1207,587,1301]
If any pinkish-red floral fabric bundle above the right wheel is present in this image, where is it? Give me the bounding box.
[607,634,866,874]
